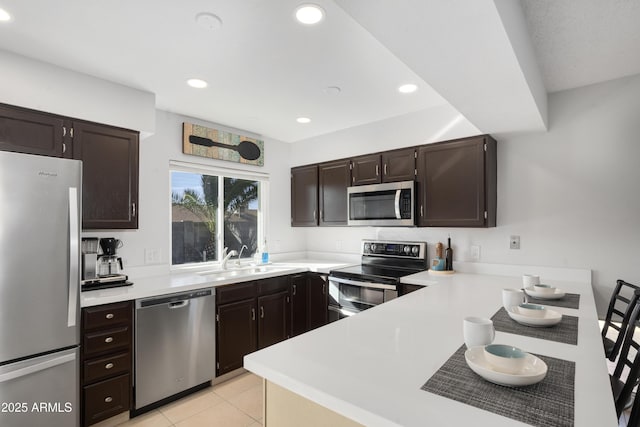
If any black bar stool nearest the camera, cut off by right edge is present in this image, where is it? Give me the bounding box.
[609,300,640,425]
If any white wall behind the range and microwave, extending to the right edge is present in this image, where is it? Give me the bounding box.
[292,76,640,315]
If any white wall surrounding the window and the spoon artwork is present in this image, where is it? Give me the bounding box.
[83,110,305,277]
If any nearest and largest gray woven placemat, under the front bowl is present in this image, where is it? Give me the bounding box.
[421,345,575,427]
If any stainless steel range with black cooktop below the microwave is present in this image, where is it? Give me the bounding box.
[329,240,427,322]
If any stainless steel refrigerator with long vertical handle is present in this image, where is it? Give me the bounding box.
[0,152,82,427]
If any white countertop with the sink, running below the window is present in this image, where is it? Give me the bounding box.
[80,259,351,307]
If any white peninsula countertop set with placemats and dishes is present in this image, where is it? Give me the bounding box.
[244,272,617,427]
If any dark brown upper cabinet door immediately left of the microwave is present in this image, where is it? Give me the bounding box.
[318,160,351,226]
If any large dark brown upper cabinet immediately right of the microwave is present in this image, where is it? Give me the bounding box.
[417,135,496,227]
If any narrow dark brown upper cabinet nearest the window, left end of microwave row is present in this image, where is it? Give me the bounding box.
[291,165,318,227]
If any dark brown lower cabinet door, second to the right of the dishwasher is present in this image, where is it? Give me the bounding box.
[258,290,291,349]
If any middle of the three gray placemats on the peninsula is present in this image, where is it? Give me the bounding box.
[491,307,578,345]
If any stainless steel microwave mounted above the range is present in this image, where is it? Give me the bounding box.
[347,181,415,227]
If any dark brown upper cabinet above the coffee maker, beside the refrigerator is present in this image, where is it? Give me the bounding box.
[73,122,139,230]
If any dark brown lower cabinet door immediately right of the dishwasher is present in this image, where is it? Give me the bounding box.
[216,298,257,375]
